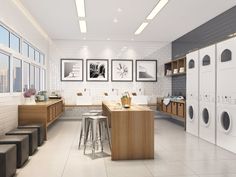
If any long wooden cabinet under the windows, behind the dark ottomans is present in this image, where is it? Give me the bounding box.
[18,100,64,140]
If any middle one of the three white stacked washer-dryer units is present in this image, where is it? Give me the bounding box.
[199,45,216,144]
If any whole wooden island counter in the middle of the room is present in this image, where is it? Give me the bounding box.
[102,102,154,160]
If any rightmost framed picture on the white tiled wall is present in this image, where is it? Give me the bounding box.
[136,60,157,82]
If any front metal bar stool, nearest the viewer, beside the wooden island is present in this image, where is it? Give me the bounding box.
[84,116,111,157]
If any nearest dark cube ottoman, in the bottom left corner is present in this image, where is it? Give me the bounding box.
[0,144,16,177]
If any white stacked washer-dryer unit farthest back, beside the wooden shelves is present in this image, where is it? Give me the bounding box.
[186,51,199,136]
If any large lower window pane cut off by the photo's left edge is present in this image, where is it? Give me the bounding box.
[0,53,10,93]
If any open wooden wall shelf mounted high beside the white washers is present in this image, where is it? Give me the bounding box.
[164,57,186,77]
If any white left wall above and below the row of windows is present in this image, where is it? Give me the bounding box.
[0,0,48,135]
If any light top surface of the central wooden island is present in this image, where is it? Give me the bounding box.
[102,101,152,111]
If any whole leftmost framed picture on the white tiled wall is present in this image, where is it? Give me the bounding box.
[61,59,84,81]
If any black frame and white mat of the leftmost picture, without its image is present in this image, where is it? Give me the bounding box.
[60,58,84,82]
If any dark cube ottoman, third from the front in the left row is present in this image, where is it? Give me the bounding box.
[6,129,38,156]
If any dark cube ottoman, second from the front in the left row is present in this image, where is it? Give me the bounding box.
[0,135,29,168]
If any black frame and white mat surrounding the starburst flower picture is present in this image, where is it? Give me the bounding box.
[111,59,134,82]
